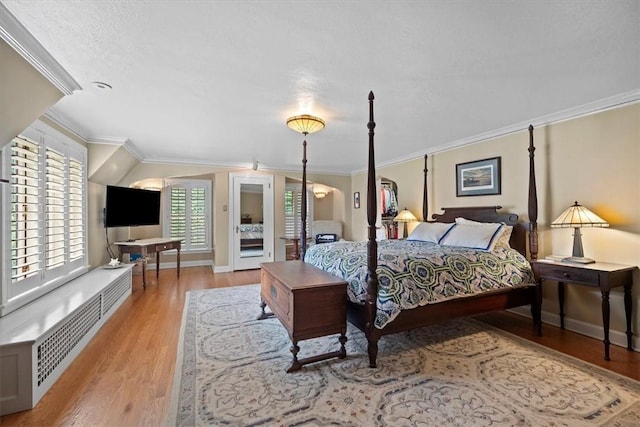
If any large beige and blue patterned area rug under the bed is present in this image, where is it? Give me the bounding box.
[168,285,640,427]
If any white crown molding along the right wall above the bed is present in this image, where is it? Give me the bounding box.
[351,89,640,175]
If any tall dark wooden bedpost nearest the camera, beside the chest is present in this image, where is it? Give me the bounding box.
[365,92,378,368]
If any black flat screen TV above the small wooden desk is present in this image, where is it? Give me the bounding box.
[104,185,160,227]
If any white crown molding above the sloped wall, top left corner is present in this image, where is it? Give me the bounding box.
[0,3,82,95]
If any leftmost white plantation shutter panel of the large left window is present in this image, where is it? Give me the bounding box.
[10,138,42,283]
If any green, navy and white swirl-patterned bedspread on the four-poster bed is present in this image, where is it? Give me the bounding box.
[304,240,534,328]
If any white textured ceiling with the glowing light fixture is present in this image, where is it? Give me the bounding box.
[2,0,640,173]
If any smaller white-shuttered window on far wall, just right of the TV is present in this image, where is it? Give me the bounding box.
[163,179,211,251]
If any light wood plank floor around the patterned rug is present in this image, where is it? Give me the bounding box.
[0,267,640,427]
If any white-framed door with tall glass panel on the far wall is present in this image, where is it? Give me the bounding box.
[229,174,274,270]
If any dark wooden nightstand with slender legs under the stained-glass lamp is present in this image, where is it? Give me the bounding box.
[531,260,638,360]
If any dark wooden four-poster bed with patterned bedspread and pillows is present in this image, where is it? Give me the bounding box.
[302,92,541,367]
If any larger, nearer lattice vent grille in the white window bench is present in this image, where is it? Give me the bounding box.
[37,296,101,386]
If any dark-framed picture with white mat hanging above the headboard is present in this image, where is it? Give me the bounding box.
[456,157,500,197]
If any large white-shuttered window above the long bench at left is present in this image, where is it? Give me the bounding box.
[0,122,88,315]
